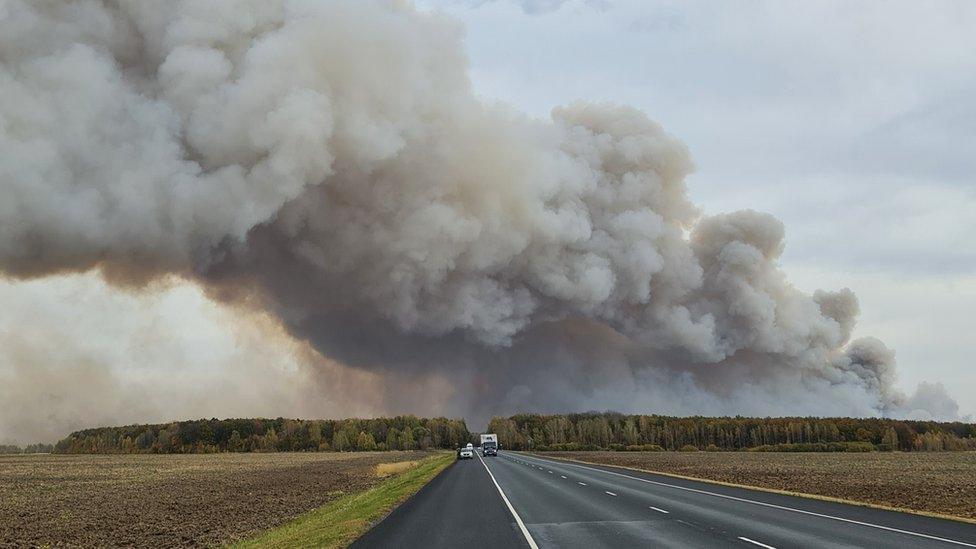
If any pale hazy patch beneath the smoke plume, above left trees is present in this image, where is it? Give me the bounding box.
[0,273,392,444]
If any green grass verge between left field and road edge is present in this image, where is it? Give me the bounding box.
[231,453,454,549]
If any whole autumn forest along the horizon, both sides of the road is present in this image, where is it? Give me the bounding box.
[47,412,976,454]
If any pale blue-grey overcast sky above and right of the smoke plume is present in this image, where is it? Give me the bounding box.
[420,0,976,414]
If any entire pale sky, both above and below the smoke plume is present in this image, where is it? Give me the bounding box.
[0,0,976,443]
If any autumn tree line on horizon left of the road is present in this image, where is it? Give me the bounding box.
[54,416,471,454]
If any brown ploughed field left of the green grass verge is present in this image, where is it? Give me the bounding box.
[0,452,428,547]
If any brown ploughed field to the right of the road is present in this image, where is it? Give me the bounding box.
[544,452,976,519]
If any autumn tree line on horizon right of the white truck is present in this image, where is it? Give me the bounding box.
[488,412,976,452]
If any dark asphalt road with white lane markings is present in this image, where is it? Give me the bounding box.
[355,452,976,548]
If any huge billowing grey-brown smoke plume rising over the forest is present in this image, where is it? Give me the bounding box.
[0,0,955,424]
